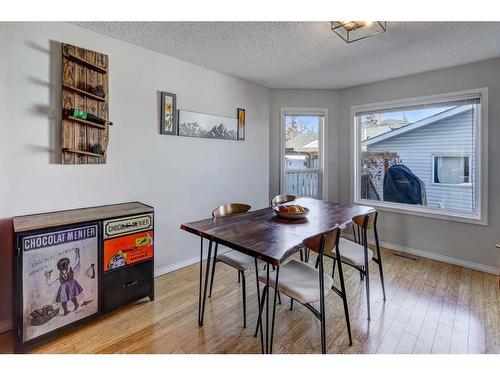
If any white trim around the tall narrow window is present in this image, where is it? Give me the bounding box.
[279,107,328,201]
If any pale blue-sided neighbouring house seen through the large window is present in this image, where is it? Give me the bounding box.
[361,106,475,212]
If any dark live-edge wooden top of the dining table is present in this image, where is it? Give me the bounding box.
[181,198,373,266]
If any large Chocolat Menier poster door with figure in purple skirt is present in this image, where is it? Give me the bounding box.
[21,224,99,342]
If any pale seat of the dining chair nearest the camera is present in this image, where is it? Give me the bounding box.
[259,259,333,304]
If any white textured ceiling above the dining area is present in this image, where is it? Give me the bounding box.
[76,22,500,89]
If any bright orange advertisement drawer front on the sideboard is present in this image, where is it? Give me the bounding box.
[103,231,154,271]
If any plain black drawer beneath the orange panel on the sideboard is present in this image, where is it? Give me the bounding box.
[102,261,153,312]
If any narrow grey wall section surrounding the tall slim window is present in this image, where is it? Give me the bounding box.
[269,90,339,201]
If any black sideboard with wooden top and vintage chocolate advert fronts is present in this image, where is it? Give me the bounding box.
[13,202,154,352]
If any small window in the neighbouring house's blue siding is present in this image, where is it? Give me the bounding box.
[433,155,470,185]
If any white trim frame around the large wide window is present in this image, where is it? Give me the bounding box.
[350,87,488,225]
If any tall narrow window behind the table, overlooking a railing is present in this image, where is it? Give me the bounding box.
[281,109,326,199]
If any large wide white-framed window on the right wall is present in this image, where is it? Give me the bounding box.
[352,89,487,223]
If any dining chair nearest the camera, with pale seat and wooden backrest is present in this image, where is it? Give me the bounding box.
[254,226,352,354]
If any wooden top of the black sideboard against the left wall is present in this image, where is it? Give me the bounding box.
[12,202,153,233]
